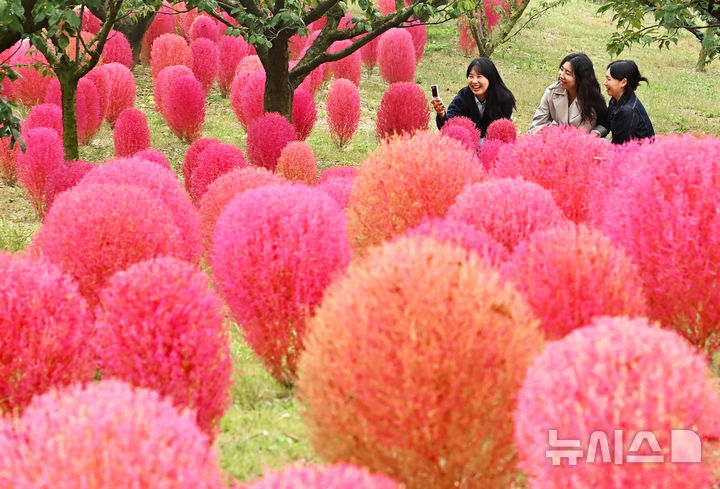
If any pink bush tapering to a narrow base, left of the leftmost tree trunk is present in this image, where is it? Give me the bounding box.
[17,127,65,216]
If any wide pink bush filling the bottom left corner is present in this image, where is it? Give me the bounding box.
[0,380,224,489]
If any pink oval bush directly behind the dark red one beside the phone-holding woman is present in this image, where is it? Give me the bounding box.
[377,28,415,83]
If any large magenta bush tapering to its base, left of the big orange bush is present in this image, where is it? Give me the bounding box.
[212,184,350,383]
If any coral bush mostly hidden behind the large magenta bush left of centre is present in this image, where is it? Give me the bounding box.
[199,166,287,251]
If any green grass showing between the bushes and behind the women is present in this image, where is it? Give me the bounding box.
[0,0,720,480]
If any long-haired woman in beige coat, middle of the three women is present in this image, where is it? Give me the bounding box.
[528,53,608,137]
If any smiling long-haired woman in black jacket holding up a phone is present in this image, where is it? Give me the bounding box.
[431,58,515,138]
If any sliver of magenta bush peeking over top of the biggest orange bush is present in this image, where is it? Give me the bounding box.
[406,217,508,267]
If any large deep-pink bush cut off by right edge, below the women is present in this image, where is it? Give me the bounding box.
[602,134,720,353]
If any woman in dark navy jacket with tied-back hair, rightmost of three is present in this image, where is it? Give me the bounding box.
[604,59,655,144]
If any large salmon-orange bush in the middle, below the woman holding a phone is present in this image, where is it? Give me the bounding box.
[348,132,486,250]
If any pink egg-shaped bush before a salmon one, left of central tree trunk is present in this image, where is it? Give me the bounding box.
[163,75,205,141]
